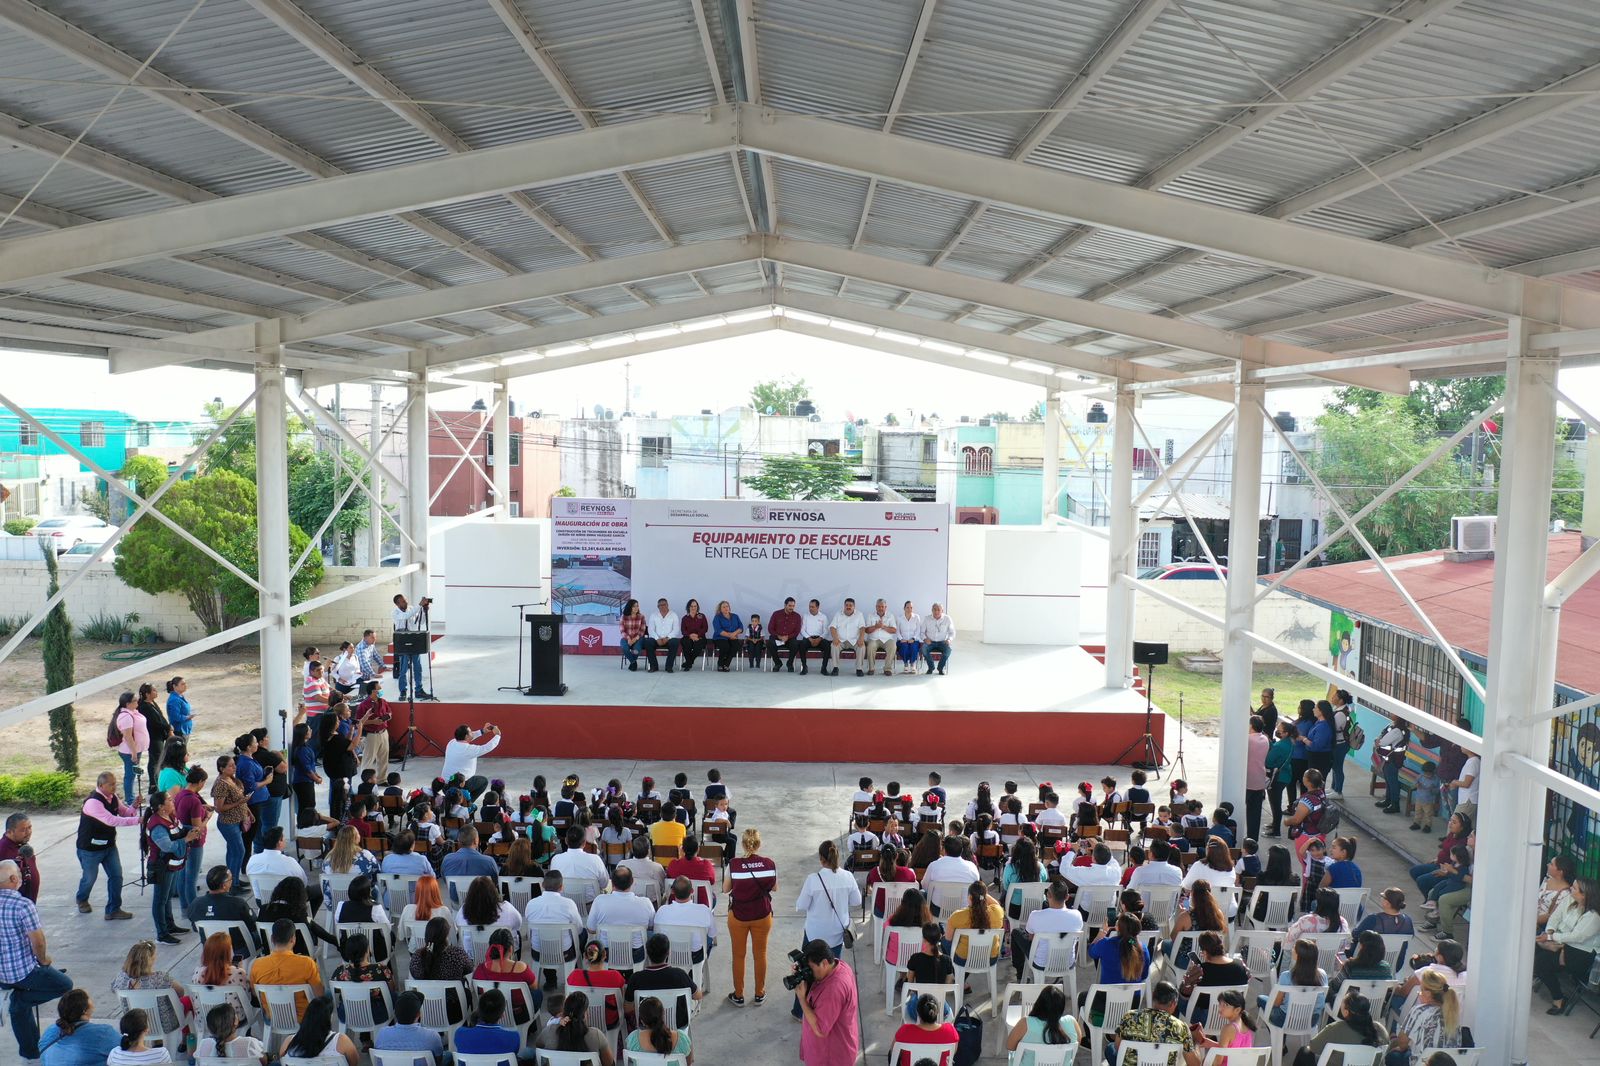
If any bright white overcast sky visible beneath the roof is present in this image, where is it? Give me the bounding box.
[0,330,1600,431]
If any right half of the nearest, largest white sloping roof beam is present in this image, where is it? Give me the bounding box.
[741,112,1600,328]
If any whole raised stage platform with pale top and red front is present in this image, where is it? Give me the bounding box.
[395,637,1165,763]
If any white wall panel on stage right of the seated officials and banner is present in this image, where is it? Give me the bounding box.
[979,527,1082,645]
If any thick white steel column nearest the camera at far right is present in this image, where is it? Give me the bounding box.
[1467,319,1558,1063]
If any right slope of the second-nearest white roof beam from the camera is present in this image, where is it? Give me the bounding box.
[768,240,1410,392]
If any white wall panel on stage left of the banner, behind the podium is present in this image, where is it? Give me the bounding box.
[434,519,549,637]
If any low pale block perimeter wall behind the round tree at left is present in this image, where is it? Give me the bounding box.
[0,562,400,647]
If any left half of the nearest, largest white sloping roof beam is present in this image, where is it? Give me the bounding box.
[0,110,734,285]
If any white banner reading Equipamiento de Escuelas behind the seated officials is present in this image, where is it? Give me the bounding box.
[627,499,950,621]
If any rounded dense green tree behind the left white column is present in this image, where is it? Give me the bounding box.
[117,471,323,634]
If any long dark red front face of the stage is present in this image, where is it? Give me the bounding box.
[390,703,1166,765]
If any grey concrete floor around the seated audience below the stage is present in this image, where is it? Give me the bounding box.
[18,717,1600,1066]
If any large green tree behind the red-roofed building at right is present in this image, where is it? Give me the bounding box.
[1307,395,1465,562]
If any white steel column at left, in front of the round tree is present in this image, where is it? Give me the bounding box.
[256,332,294,738]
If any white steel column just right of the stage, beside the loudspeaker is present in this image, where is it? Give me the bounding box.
[1218,377,1266,810]
